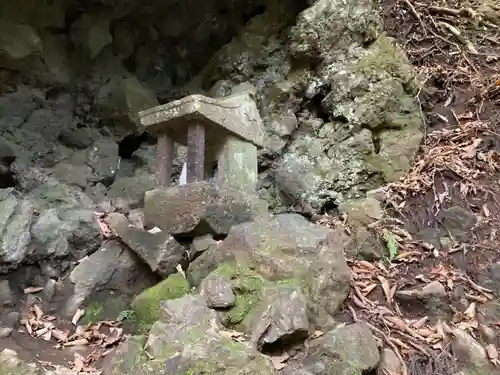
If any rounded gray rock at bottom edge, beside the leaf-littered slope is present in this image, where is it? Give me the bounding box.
[303,323,380,375]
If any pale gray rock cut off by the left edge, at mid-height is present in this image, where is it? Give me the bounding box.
[0,188,34,270]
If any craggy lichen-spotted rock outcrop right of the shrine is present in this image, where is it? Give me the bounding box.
[191,0,423,211]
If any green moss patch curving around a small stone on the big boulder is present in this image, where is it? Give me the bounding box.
[213,262,270,328]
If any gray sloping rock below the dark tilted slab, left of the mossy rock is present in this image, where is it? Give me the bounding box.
[64,240,151,317]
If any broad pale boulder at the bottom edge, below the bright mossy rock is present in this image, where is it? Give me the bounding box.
[103,295,275,375]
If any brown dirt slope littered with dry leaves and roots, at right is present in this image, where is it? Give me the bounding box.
[343,0,500,375]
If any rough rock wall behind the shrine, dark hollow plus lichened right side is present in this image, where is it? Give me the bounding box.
[0,0,422,271]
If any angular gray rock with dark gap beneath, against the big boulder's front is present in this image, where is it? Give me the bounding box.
[247,285,310,348]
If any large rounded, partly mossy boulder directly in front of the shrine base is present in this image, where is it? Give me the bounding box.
[188,214,351,332]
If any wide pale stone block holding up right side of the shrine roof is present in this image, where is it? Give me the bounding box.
[216,136,258,193]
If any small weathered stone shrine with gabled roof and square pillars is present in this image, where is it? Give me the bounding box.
[139,86,267,237]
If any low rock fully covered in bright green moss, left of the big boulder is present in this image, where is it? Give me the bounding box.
[131,273,190,331]
